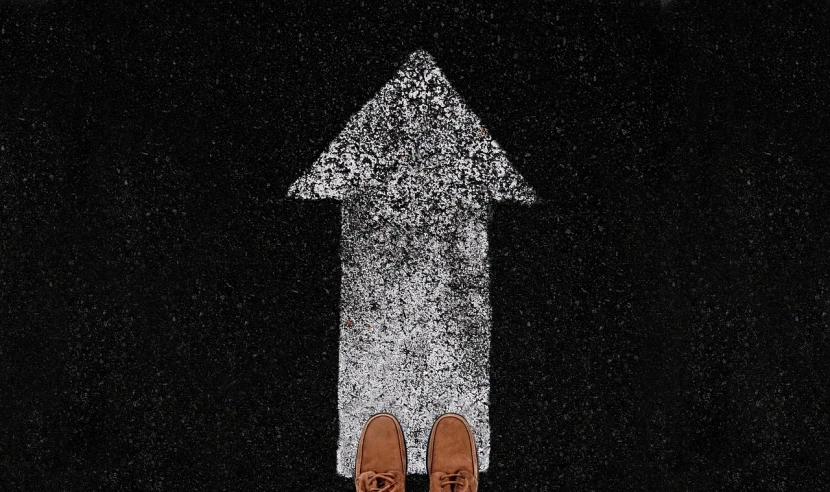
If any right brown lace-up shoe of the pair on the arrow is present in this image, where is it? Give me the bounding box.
[427,413,478,492]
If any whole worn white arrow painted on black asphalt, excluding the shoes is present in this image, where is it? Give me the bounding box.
[289,51,535,476]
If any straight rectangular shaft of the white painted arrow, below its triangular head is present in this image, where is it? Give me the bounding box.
[337,197,491,476]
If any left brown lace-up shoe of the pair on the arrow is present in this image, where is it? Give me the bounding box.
[354,413,406,492]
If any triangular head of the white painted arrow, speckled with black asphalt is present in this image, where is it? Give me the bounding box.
[288,51,535,203]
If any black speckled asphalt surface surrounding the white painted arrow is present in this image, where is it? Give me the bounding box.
[0,1,830,491]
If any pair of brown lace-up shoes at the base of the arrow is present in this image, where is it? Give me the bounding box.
[354,413,478,492]
